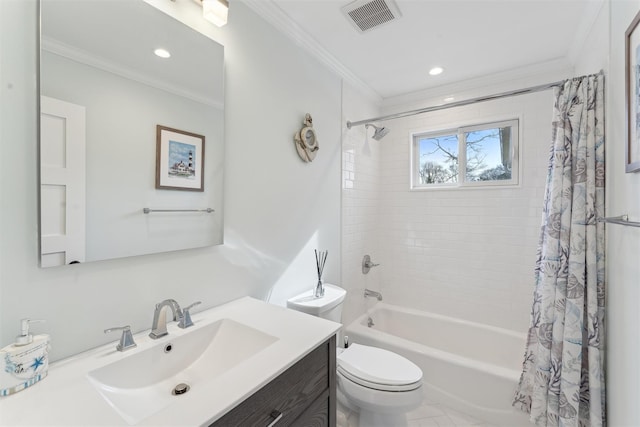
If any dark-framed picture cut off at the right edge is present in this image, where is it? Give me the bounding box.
[625,12,640,173]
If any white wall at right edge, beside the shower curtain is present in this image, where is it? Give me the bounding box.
[600,0,640,426]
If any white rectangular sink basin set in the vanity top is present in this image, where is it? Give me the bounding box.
[88,319,278,424]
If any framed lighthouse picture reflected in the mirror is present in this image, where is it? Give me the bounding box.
[156,125,204,191]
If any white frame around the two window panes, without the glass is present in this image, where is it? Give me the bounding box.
[409,117,522,191]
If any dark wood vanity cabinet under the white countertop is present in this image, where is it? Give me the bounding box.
[210,336,336,427]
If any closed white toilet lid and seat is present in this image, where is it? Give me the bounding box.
[337,344,422,391]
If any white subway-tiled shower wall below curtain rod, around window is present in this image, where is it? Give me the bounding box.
[342,91,553,332]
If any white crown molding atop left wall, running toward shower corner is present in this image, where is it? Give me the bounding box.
[243,0,383,104]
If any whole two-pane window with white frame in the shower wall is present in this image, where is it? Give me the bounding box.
[412,120,518,189]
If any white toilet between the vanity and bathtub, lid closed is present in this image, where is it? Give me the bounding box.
[287,284,422,427]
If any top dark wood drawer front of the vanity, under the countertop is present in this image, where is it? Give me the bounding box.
[212,337,335,427]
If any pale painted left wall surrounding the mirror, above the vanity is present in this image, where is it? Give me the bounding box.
[0,0,341,360]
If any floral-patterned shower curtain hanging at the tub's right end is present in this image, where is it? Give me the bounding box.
[513,73,605,427]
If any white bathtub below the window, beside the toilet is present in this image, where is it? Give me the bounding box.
[344,303,531,427]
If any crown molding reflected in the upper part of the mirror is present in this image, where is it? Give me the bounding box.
[41,37,224,110]
